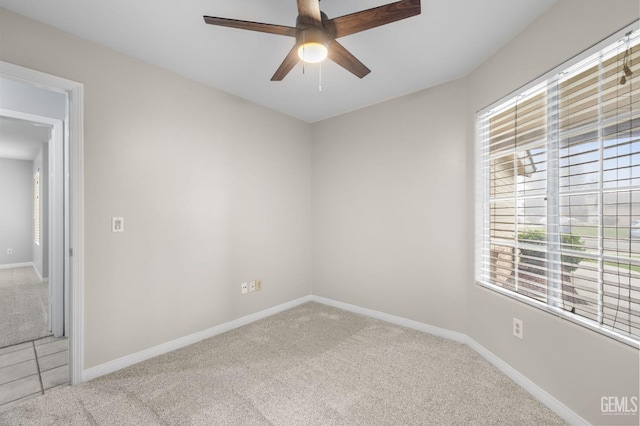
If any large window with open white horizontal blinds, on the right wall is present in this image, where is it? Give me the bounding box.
[476,25,640,347]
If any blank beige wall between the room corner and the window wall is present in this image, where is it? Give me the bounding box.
[313,82,471,332]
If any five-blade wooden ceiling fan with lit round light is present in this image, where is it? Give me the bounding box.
[204,0,420,81]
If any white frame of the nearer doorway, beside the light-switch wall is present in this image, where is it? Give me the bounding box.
[0,61,84,385]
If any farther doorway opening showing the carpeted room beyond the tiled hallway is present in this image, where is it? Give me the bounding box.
[0,115,56,348]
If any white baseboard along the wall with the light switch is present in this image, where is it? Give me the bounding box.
[82,296,312,382]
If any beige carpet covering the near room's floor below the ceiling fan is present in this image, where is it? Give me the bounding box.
[0,303,563,425]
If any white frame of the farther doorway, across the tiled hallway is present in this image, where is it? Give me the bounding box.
[0,108,64,337]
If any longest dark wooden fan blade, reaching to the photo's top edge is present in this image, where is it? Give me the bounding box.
[324,0,420,38]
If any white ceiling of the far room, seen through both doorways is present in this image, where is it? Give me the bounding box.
[0,116,51,161]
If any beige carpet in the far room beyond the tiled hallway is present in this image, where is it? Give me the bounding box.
[0,266,51,348]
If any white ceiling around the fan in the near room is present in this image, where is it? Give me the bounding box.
[0,0,558,122]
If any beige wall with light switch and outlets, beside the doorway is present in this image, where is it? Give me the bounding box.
[0,10,311,368]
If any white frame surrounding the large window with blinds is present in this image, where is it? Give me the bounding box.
[474,21,640,348]
